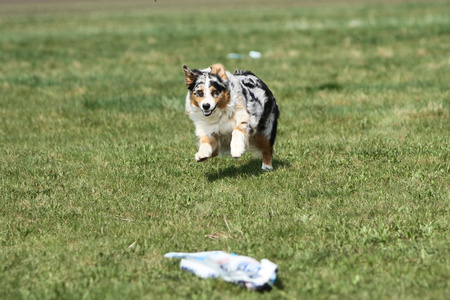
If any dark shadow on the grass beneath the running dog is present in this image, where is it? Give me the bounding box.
[206,159,290,181]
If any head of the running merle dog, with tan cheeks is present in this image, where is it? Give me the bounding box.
[183,64,230,117]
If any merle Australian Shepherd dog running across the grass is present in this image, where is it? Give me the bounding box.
[183,64,280,170]
